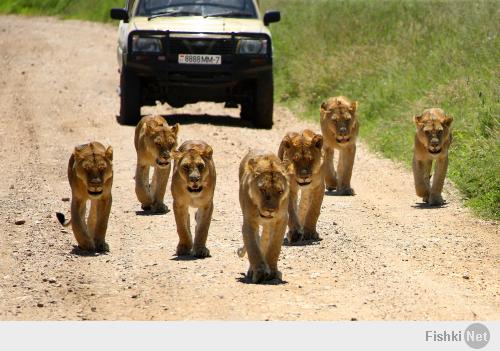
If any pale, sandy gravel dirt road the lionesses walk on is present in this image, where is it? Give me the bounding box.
[0,17,500,320]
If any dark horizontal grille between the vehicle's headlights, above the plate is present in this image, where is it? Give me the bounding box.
[167,38,235,55]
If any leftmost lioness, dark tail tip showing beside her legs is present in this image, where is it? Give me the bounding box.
[56,141,113,251]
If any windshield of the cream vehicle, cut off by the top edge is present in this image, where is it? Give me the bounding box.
[136,0,257,19]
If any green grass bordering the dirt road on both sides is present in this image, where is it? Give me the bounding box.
[0,0,500,220]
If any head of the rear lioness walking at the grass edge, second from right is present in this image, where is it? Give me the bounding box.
[320,96,358,144]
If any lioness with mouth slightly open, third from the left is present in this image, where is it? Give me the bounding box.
[172,140,217,258]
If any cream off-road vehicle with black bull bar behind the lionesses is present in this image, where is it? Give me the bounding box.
[110,0,280,128]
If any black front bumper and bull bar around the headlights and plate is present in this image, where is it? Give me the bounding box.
[123,31,272,89]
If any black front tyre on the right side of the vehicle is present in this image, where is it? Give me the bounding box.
[240,72,274,129]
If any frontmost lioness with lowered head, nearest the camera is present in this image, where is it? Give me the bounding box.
[238,150,290,283]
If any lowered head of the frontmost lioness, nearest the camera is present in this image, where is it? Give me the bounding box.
[246,154,289,219]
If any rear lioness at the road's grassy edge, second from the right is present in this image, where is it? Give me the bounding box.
[320,96,359,195]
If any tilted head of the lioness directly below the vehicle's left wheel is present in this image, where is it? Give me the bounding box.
[145,116,179,168]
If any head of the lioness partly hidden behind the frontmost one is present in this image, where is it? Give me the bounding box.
[278,129,323,186]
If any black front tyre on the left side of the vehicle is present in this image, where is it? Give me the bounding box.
[118,69,141,126]
